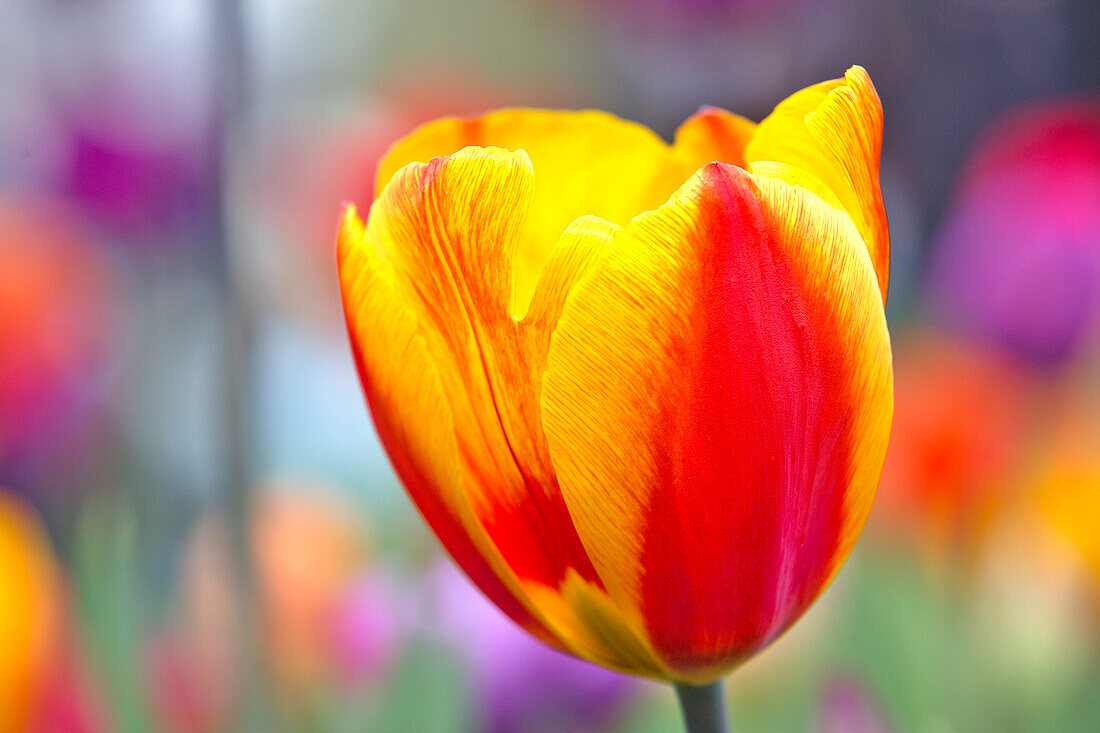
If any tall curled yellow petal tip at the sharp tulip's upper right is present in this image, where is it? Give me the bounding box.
[745,66,890,300]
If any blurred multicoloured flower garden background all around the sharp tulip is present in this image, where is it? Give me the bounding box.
[0,0,1100,733]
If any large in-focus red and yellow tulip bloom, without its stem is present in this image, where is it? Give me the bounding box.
[338,67,892,683]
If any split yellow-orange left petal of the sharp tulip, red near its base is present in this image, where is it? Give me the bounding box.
[339,147,653,671]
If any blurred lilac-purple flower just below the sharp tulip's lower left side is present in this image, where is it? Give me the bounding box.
[430,562,642,733]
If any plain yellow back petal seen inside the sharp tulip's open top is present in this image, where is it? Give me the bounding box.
[377,109,690,316]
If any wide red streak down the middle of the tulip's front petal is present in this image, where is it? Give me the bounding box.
[641,166,851,669]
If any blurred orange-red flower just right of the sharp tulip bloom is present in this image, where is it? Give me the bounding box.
[871,333,1029,553]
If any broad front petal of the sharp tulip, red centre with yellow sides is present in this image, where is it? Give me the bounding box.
[542,164,892,681]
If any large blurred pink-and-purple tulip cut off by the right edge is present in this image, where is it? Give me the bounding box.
[931,102,1100,367]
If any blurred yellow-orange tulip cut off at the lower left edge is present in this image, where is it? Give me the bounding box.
[0,492,59,733]
